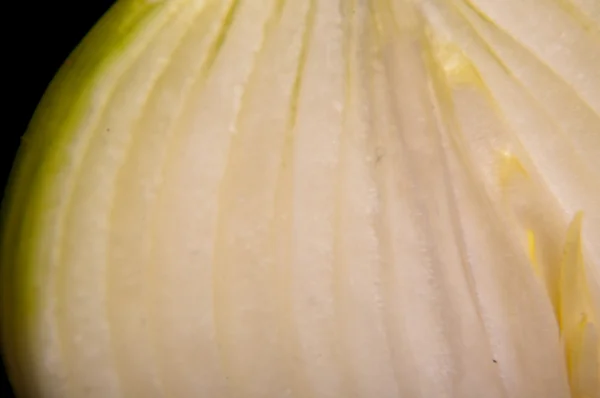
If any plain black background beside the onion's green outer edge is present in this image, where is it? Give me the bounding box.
[0,0,115,398]
